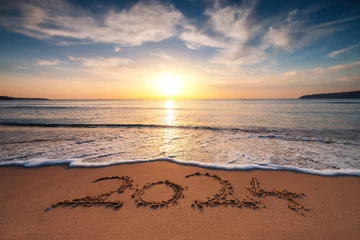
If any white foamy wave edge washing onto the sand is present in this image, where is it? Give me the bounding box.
[0,158,360,176]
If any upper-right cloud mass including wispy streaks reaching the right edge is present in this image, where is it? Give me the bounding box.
[179,1,358,66]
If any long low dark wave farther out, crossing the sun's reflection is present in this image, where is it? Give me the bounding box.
[0,121,360,146]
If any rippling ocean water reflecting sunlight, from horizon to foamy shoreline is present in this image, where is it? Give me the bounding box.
[0,99,360,175]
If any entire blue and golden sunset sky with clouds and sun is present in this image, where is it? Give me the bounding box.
[0,0,360,99]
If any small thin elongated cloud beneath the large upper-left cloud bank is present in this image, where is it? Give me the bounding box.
[69,56,133,68]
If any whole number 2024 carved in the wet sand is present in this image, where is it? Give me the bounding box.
[47,172,310,215]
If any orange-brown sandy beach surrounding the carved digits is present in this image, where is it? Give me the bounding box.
[0,162,360,239]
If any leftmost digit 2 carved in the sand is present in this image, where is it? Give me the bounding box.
[47,176,133,210]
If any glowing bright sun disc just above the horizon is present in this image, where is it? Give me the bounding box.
[156,73,182,97]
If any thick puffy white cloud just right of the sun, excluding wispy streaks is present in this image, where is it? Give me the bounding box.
[179,2,267,67]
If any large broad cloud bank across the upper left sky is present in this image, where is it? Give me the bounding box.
[0,0,185,46]
